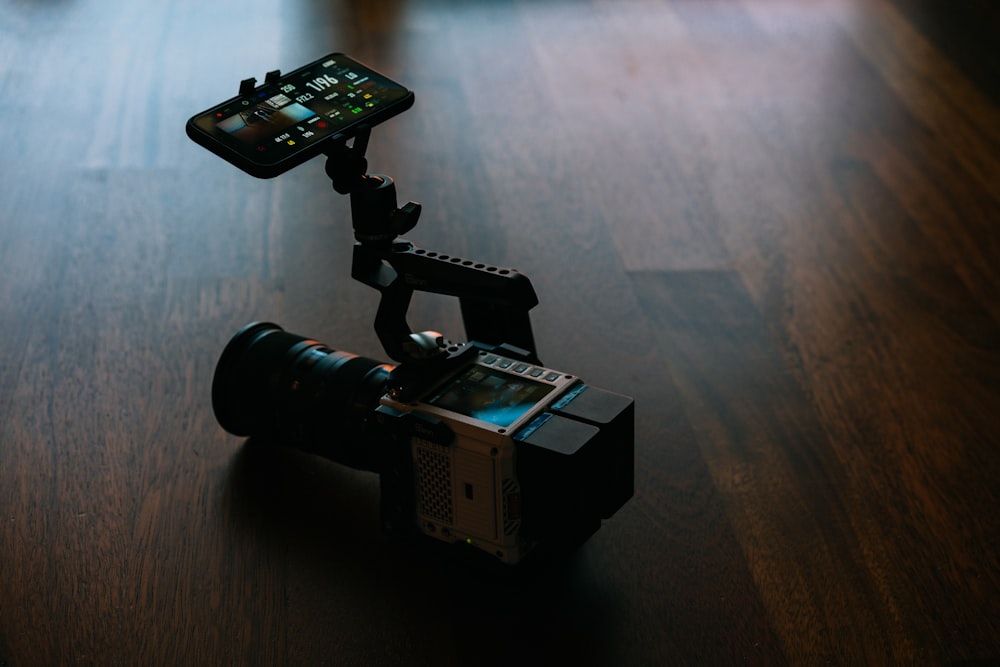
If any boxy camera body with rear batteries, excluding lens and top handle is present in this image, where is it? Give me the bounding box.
[376,342,634,564]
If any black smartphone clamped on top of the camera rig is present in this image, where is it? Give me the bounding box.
[186,53,413,178]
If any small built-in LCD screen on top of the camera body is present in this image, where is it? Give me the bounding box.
[426,366,553,428]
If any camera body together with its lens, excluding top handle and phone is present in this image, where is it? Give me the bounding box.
[212,323,634,564]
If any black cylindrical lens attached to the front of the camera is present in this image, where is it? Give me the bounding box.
[212,322,392,469]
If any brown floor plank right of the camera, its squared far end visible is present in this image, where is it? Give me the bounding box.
[634,272,934,662]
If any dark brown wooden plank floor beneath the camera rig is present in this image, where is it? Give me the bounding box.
[0,0,1000,667]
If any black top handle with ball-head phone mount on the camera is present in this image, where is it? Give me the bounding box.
[326,127,540,400]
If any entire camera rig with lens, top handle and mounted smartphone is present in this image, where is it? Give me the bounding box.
[187,54,634,564]
